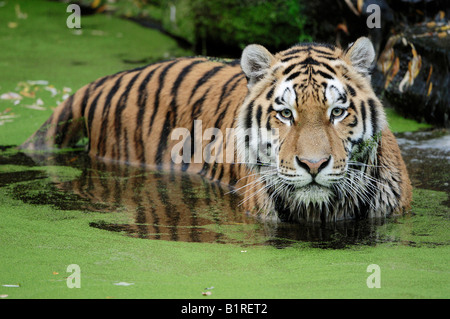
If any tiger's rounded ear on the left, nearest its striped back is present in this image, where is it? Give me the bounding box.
[241,44,275,89]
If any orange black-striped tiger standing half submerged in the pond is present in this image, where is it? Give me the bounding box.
[20,37,412,223]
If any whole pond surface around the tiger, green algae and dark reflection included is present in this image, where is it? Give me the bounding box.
[0,1,450,299]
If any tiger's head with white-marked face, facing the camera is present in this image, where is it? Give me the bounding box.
[237,37,387,219]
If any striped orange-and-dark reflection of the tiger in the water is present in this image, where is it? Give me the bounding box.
[18,152,390,248]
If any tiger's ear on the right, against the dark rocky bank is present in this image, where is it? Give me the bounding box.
[345,37,375,78]
